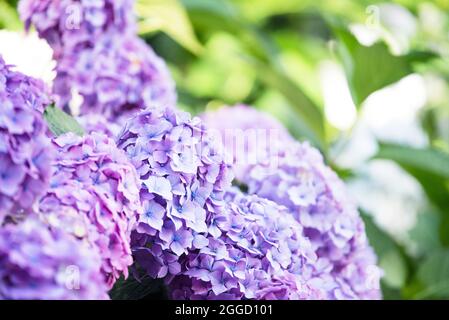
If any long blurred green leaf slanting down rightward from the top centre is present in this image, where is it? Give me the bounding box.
[183,0,327,152]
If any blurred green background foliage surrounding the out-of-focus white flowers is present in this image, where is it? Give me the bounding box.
[4,0,449,299]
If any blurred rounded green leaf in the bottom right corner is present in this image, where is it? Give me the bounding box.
[414,249,449,299]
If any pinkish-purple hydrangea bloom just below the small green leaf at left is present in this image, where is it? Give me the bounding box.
[40,133,141,286]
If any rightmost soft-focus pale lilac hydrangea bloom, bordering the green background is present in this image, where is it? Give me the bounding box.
[201,108,381,299]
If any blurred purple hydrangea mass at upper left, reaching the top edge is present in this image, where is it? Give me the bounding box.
[20,0,176,120]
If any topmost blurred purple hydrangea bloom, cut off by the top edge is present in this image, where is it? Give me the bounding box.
[18,0,136,59]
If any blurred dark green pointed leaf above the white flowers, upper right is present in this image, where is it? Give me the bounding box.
[334,27,435,107]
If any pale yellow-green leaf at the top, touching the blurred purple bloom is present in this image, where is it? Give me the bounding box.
[136,0,203,54]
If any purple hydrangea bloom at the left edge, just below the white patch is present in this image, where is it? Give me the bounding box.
[0,57,53,221]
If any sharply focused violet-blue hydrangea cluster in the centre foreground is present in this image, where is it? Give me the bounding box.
[118,108,340,299]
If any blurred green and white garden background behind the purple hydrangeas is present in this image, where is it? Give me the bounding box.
[0,0,449,299]
